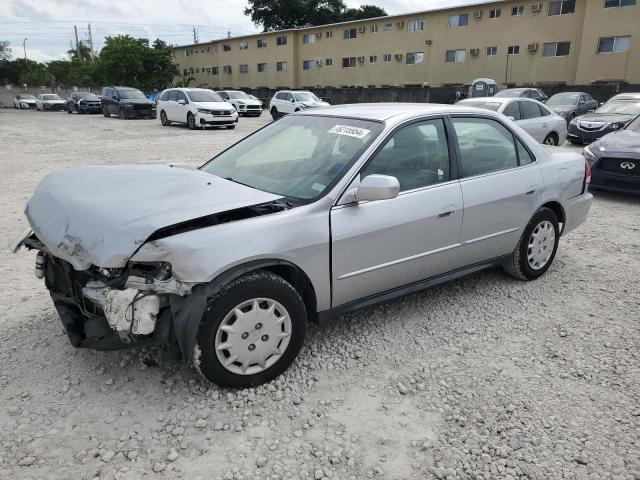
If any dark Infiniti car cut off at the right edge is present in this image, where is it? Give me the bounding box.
[584,116,640,194]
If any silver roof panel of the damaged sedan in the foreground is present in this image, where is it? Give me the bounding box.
[303,103,500,122]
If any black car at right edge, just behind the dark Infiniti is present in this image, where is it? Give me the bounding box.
[569,97,640,144]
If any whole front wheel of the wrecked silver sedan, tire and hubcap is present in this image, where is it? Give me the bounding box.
[193,271,307,388]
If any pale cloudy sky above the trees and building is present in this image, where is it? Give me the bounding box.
[0,0,481,62]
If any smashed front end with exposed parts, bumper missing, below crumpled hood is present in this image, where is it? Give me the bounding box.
[16,234,190,350]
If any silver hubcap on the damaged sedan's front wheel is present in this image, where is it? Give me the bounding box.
[215,298,291,375]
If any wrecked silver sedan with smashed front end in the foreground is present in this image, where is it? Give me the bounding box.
[13,103,592,387]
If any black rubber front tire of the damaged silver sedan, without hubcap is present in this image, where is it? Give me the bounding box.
[194,270,307,388]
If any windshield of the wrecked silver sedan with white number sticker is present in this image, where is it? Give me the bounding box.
[202,115,382,200]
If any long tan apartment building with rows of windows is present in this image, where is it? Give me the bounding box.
[174,0,640,88]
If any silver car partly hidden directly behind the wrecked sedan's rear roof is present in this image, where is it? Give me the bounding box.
[458,96,567,145]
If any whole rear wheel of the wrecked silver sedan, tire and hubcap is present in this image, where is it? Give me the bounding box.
[504,207,560,280]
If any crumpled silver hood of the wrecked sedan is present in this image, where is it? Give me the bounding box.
[25,165,281,270]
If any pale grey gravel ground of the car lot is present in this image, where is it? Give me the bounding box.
[0,110,640,480]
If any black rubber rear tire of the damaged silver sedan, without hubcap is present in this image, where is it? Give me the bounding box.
[503,207,560,280]
